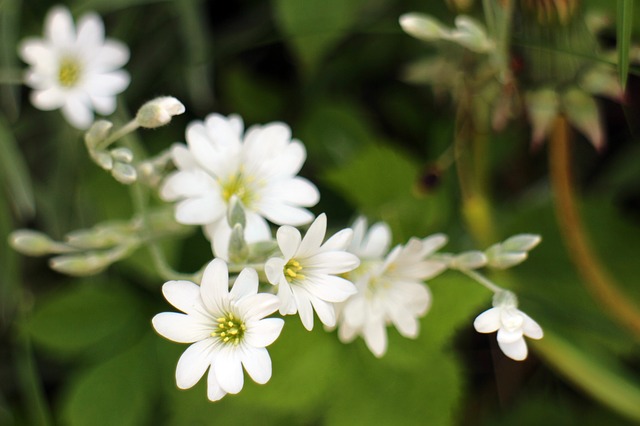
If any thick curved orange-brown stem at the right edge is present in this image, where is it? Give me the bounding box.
[549,116,640,338]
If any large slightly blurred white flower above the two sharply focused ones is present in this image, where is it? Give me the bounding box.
[160,114,320,246]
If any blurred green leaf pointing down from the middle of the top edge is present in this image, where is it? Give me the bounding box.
[274,0,362,72]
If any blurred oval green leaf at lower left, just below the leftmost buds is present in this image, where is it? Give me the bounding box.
[25,280,140,356]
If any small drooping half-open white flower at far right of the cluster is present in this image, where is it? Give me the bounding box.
[473,291,543,361]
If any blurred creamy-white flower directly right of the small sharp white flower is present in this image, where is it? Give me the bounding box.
[338,218,446,357]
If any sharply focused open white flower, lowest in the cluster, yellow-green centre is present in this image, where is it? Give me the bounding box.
[152,259,284,401]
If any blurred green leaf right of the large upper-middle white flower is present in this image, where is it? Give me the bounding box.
[324,145,451,241]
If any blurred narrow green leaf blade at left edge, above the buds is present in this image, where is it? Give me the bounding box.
[0,117,35,218]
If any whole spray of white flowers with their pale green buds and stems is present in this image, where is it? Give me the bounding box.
[11,7,542,401]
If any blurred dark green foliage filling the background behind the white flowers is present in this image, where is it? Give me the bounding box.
[0,0,640,426]
